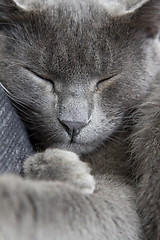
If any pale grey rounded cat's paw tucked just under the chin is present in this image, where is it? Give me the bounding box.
[24,149,95,194]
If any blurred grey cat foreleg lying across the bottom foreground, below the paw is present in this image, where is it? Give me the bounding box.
[0,175,140,240]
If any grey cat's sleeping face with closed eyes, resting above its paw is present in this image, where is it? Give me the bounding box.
[0,0,160,154]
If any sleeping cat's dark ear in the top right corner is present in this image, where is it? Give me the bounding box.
[131,0,160,37]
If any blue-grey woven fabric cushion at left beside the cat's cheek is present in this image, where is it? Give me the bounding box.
[0,85,33,174]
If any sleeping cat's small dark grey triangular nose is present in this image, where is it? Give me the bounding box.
[60,120,87,140]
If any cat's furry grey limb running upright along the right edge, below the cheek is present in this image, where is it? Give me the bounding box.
[132,81,160,240]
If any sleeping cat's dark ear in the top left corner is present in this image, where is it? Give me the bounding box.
[0,0,25,25]
